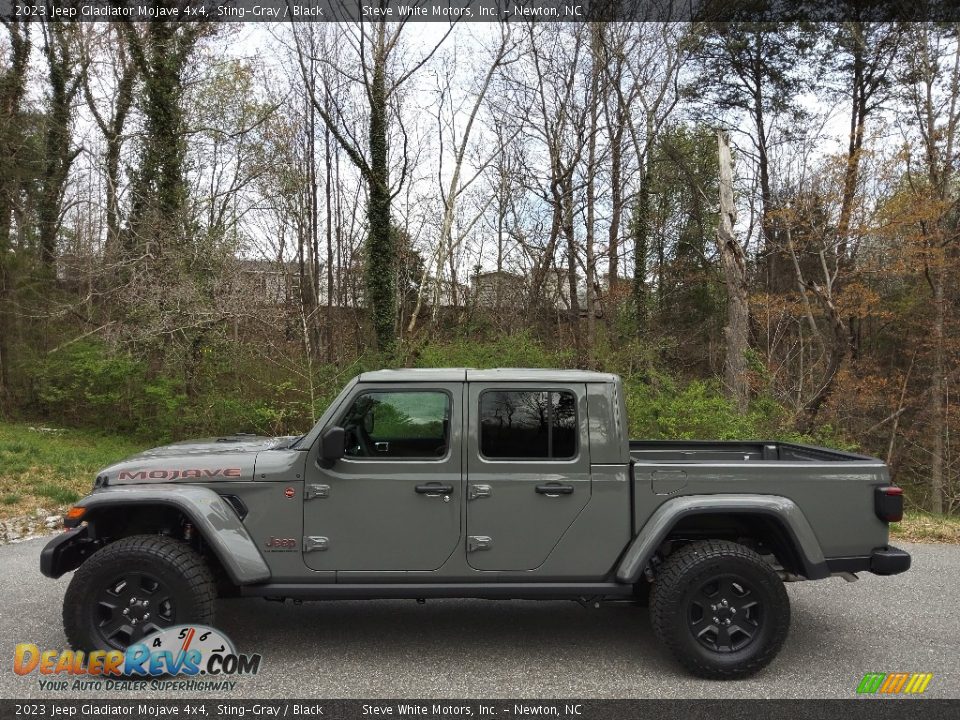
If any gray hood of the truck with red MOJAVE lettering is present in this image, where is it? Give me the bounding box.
[95,435,294,487]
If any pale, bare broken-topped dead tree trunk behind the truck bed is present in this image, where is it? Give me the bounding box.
[716,132,750,412]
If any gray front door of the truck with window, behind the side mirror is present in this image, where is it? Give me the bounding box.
[303,383,463,571]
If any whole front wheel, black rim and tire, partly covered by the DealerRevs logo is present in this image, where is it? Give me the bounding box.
[63,535,216,652]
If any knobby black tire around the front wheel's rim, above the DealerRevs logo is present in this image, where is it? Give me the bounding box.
[63,535,217,652]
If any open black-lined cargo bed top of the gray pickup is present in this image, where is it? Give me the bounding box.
[630,440,879,464]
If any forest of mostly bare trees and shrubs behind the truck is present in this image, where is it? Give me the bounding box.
[0,18,960,515]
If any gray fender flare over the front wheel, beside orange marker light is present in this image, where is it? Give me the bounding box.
[56,484,270,585]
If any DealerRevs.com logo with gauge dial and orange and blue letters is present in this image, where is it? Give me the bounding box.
[13,625,261,692]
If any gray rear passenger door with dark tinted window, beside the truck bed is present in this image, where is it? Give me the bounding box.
[466,383,591,571]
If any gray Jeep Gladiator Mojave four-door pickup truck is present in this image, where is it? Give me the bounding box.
[40,369,910,678]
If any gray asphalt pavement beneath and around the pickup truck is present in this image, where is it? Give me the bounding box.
[0,540,960,699]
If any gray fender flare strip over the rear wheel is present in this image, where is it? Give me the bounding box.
[616,494,830,583]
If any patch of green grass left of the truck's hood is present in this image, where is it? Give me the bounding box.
[0,422,144,519]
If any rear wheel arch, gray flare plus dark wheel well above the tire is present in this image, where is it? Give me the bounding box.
[616,494,830,583]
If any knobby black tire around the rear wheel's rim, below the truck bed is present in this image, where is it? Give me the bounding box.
[650,540,790,680]
